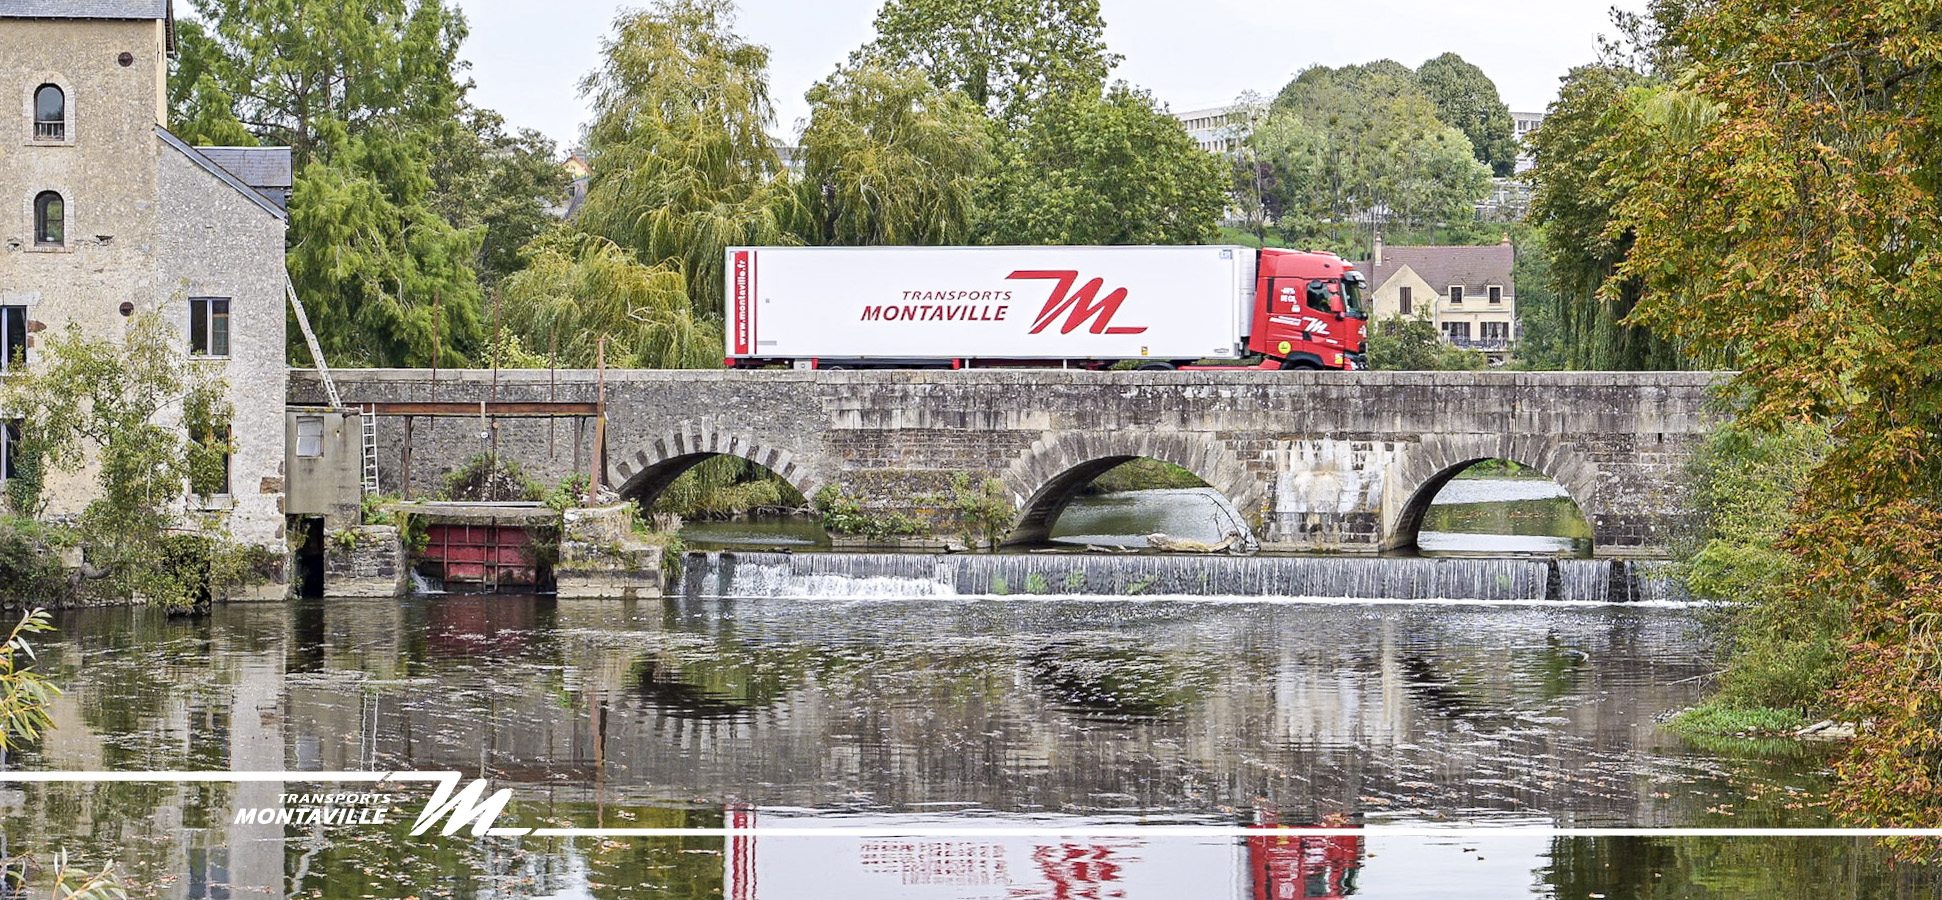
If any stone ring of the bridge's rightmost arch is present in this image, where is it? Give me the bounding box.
[1381,435,1598,550]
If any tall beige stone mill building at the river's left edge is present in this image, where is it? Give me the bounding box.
[0,0,291,546]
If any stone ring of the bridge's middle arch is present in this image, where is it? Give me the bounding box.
[1000,432,1266,546]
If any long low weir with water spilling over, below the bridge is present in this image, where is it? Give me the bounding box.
[682,550,1680,603]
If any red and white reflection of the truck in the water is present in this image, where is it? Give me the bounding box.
[722,807,1361,900]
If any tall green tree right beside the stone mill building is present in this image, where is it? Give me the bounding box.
[171,0,484,365]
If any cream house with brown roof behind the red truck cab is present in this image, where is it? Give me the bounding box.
[1356,235,1517,363]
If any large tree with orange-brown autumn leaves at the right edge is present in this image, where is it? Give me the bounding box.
[1600,0,1942,828]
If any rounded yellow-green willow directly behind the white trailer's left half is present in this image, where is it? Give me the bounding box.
[802,64,990,245]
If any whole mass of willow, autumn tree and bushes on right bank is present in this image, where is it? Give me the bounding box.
[1532,0,1942,839]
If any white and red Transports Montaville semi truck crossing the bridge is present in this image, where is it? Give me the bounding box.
[724,245,1369,369]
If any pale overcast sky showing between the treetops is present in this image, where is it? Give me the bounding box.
[454,0,1645,146]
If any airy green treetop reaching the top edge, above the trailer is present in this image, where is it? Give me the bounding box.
[851,0,1119,124]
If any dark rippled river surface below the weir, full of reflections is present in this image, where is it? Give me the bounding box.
[0,597,1913,898]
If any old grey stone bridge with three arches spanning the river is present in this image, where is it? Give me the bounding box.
[289,369,1723,556]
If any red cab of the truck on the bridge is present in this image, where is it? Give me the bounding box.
[1247,247,1369,369]
